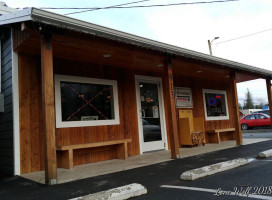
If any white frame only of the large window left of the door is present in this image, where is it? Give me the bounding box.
[55,74,120,128]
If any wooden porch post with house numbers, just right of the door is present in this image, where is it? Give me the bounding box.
[164,57,180,159]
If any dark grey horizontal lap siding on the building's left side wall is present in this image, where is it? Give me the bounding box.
[0,29,14,175]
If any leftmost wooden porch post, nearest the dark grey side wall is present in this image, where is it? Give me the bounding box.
[41,36,57,185]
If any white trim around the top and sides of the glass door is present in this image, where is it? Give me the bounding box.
[135,75,168,154]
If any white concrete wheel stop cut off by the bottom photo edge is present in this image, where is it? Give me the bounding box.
[70,183,147,200]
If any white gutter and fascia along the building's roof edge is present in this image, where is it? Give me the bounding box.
[0,8,272,78]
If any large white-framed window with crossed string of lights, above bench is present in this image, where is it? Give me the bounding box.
[55,75,119,128]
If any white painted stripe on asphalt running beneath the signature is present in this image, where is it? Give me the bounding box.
[161,185,272,200]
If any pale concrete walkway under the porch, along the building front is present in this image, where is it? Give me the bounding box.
[22,138,269,184]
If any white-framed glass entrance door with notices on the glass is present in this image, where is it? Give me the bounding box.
[136,76,167,153]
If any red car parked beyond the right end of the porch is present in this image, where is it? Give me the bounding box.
[240,113,271,130]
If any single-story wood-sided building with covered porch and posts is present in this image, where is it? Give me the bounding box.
[0,8,272,185]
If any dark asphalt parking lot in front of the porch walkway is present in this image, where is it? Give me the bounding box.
[0,140,272,200]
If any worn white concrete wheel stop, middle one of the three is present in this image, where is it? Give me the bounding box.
[180,158,248,181]
